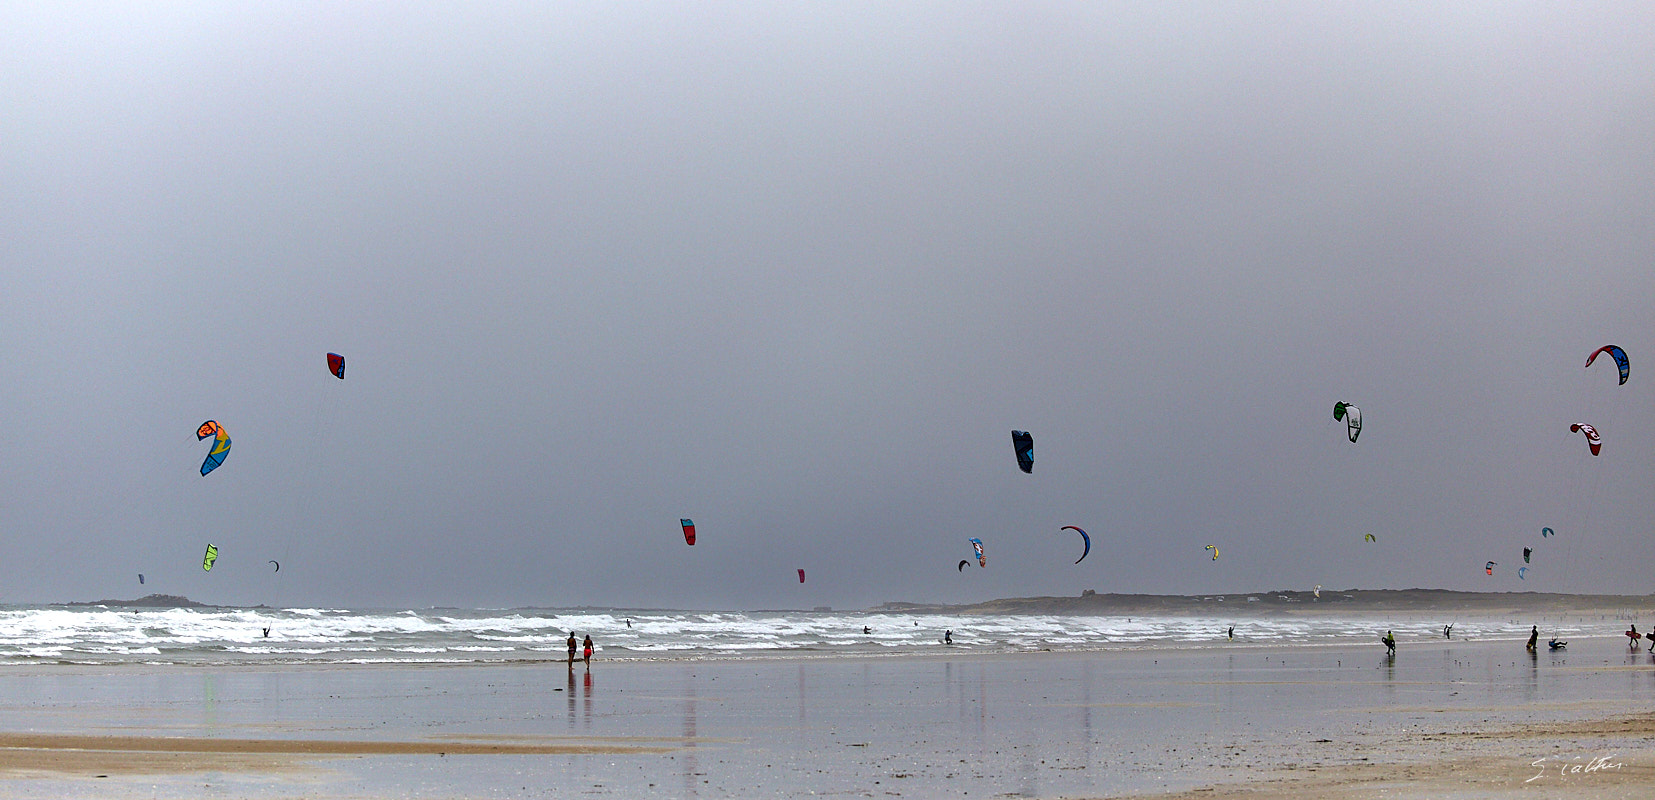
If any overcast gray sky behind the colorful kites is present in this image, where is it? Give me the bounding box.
[0,2,1655,608]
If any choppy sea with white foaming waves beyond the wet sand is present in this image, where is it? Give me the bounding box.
[0,606,1588,666]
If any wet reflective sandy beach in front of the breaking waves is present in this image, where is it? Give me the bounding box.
[0,636,1655,798]
